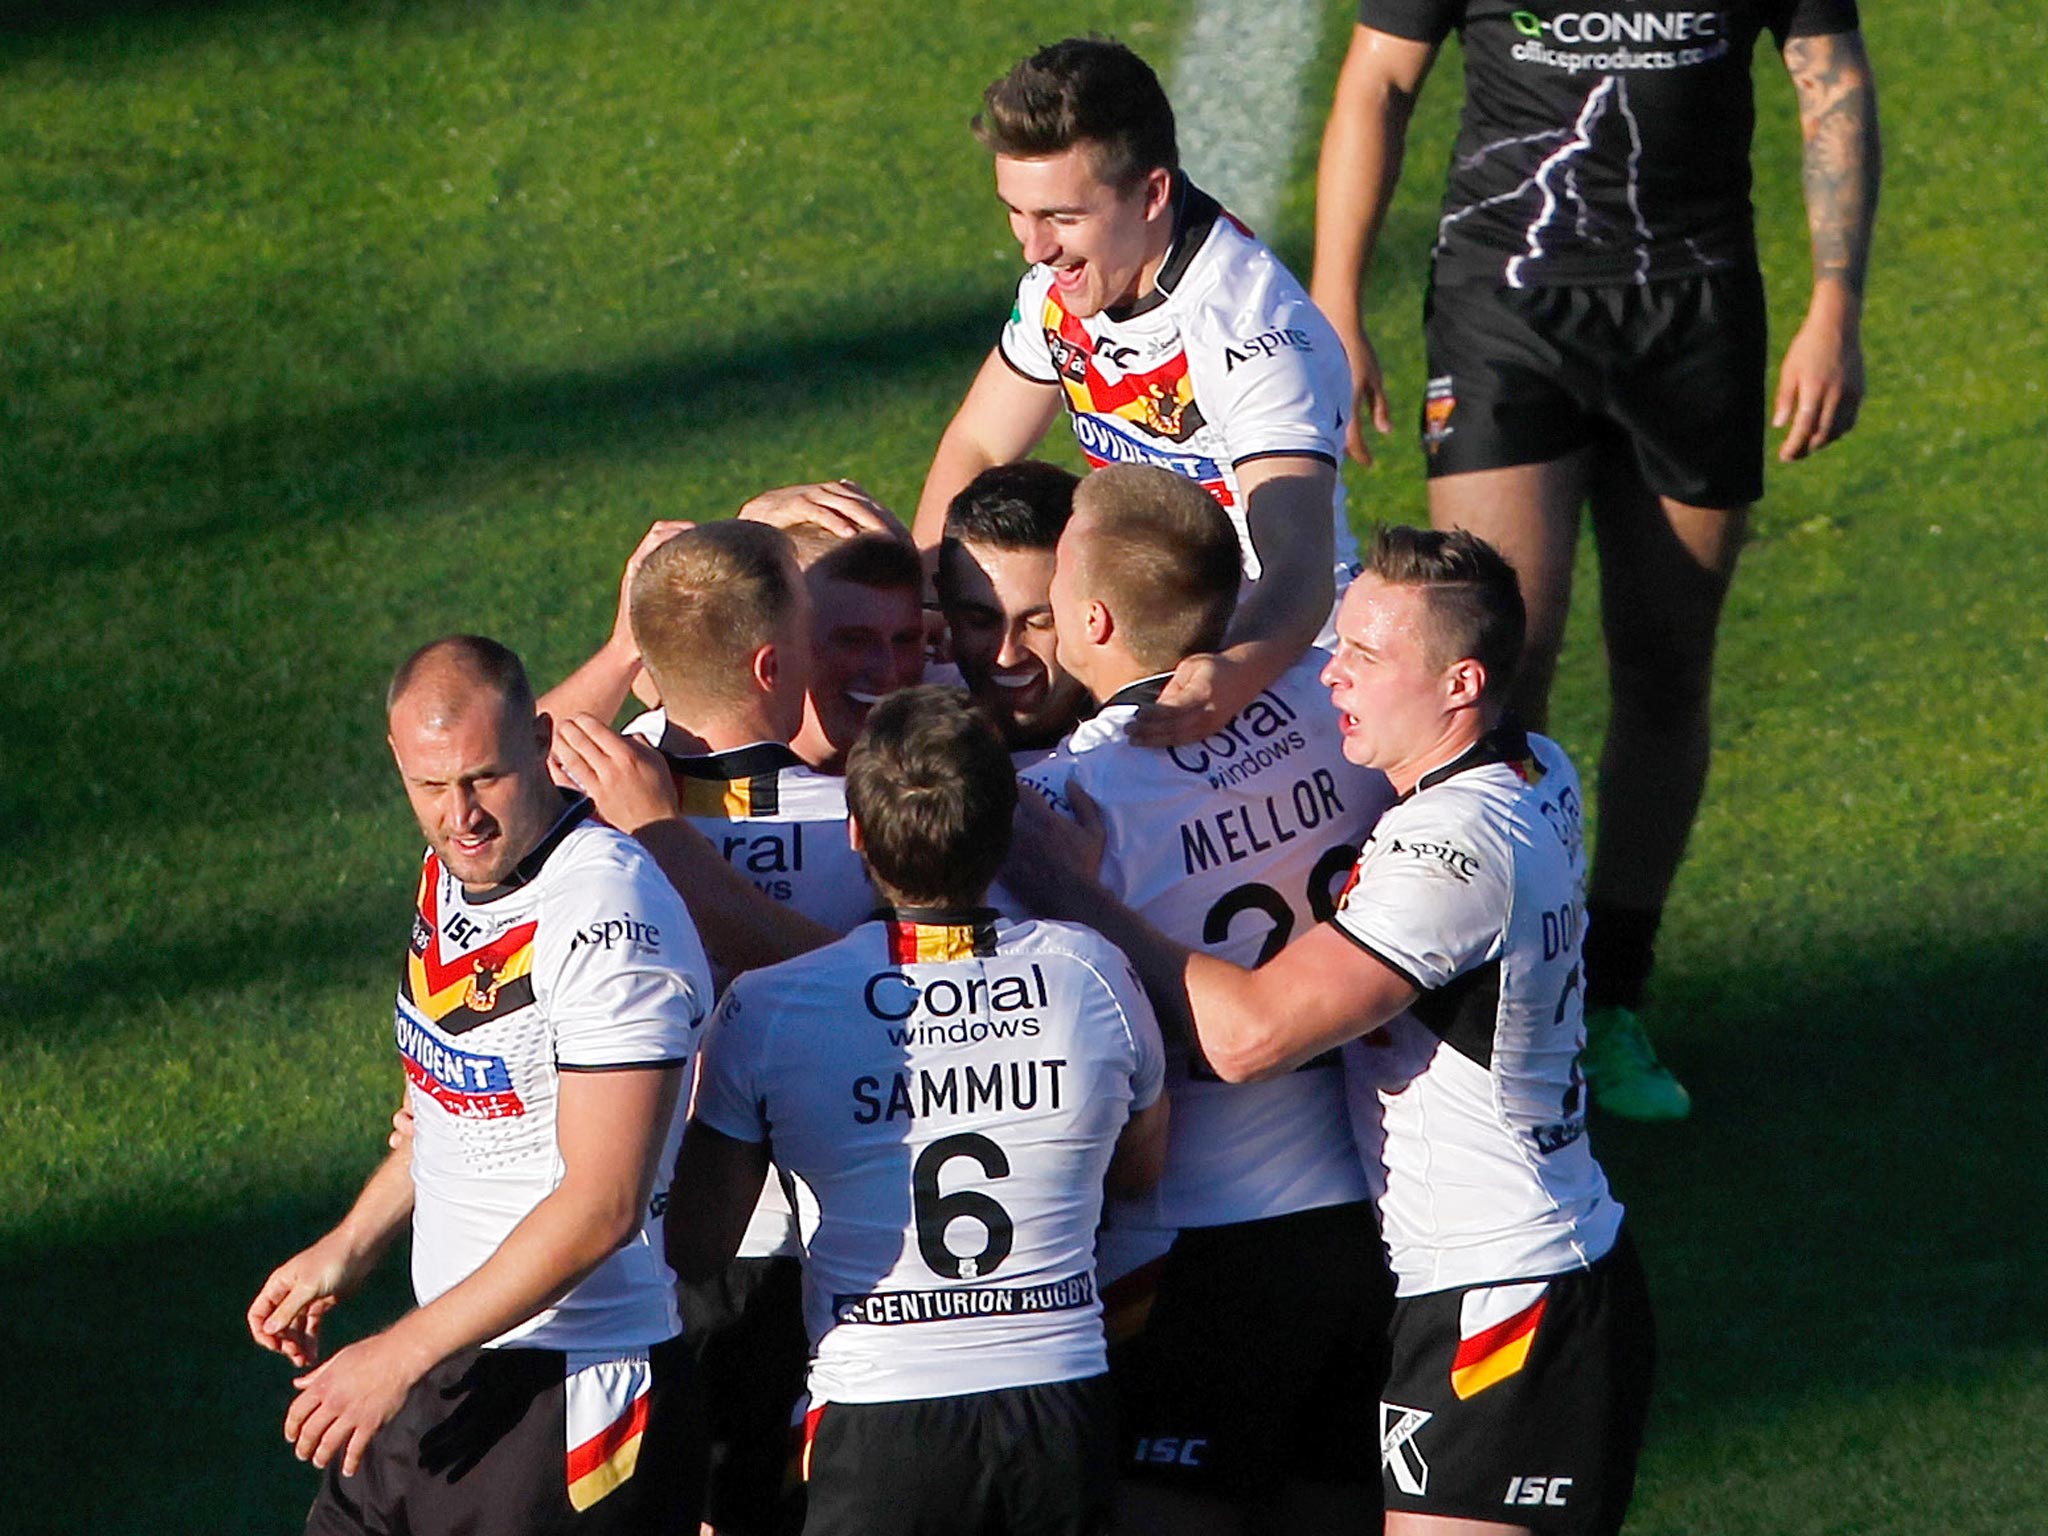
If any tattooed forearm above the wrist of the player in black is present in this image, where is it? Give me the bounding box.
[1784,33,1880,297]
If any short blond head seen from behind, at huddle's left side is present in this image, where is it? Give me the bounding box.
[627,522,805,721]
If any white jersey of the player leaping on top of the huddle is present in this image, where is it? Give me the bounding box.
[997,176,1358,584]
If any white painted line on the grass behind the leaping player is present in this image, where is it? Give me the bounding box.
[1169,0,1323,240]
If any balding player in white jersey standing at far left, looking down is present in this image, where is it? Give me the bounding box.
[248,635,711,1536]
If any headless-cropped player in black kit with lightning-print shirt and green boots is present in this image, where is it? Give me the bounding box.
[1311,0,1878,1120]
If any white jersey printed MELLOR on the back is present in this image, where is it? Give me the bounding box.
[1024,649,1395,1227]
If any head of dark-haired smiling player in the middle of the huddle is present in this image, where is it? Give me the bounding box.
[936,459,1090,772]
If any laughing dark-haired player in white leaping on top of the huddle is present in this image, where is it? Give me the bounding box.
[913,37,1356,741]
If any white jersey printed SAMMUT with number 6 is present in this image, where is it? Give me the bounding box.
[696,909,1163,1403]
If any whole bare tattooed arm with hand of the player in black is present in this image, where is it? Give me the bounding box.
[1772,33,1882,463]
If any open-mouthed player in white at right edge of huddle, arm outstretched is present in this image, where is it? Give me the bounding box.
[1012,528,1653,1536]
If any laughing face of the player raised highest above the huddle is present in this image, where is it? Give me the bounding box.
[995,143,1174,319]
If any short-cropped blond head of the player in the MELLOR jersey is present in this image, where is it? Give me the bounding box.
[1059,465,1243,672]
